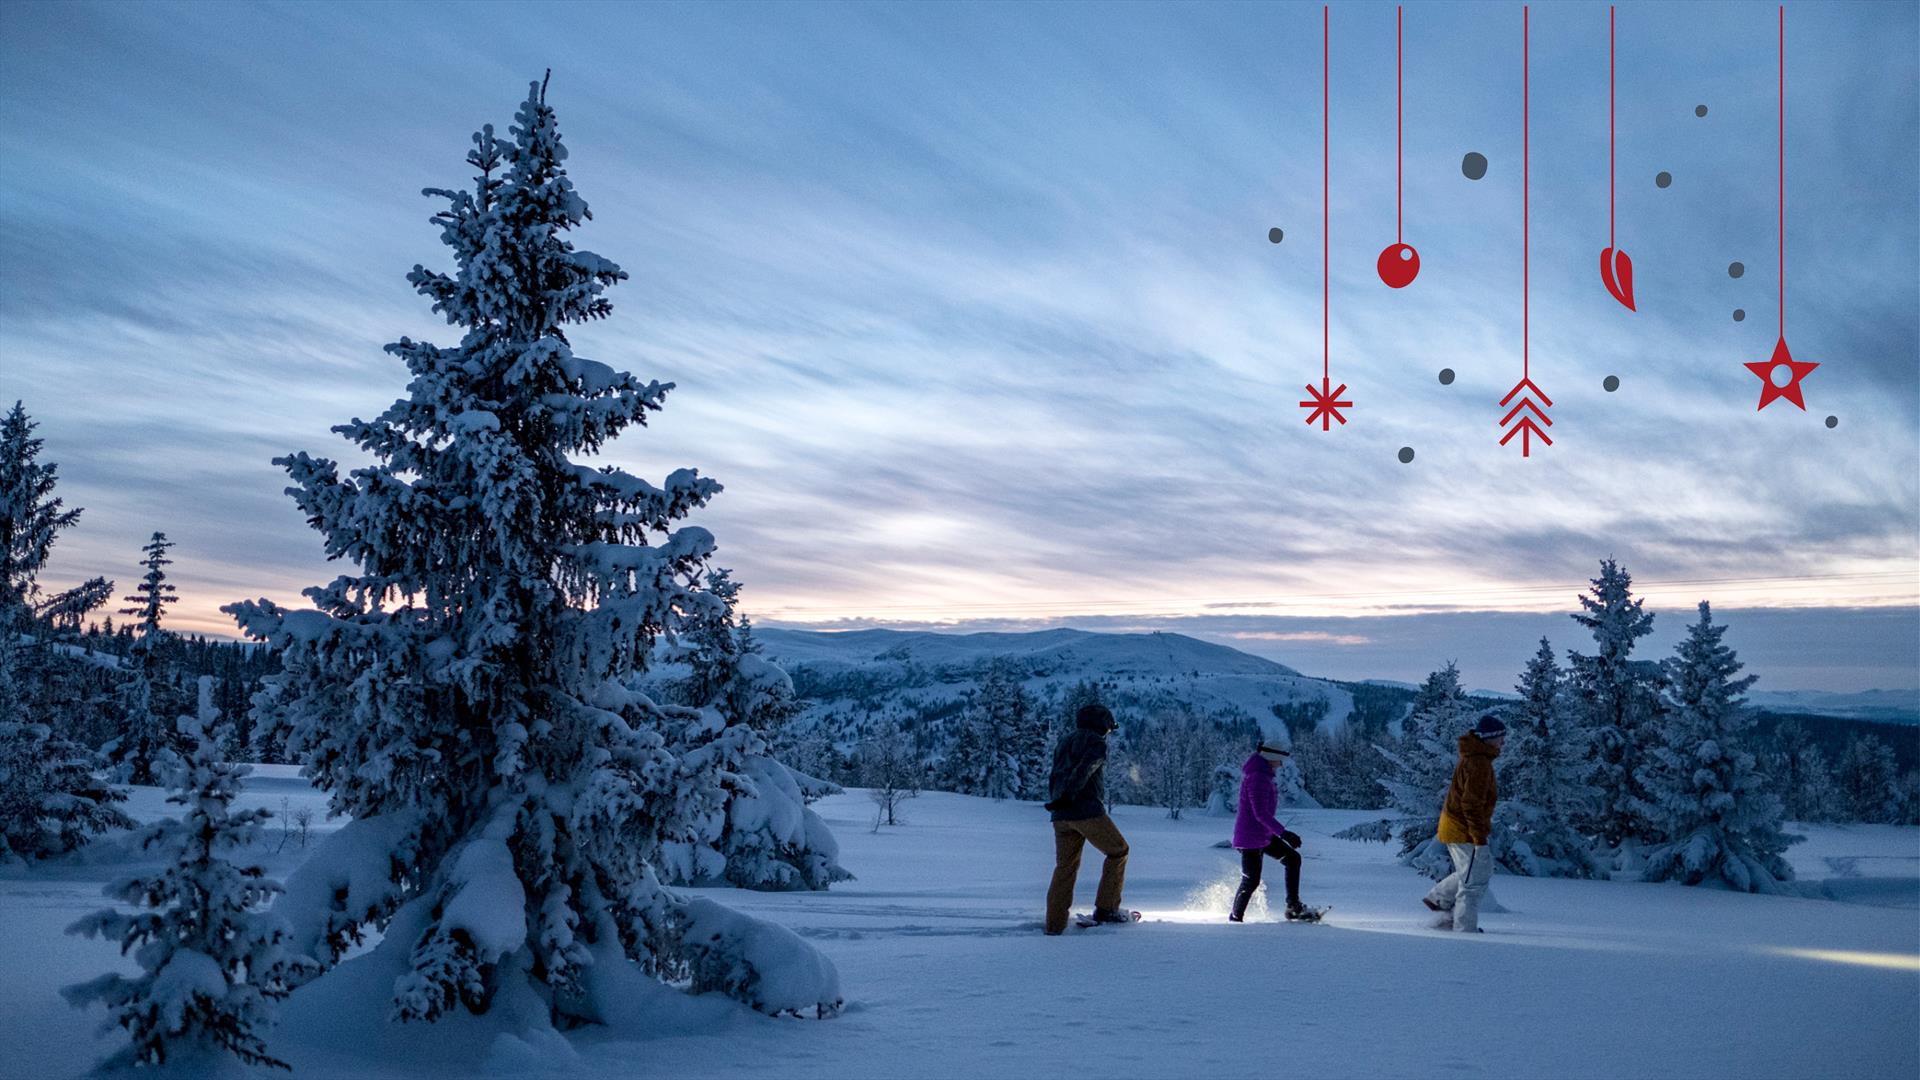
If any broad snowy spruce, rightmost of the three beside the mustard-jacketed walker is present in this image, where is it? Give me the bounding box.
[1638,600,1801,892]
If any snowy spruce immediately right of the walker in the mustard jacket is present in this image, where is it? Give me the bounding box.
[1492,638,1605,878]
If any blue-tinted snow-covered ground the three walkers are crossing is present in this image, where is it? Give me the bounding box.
[0,769,1920,1078]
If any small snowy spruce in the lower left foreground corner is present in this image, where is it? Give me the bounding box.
[61,717,311,1068]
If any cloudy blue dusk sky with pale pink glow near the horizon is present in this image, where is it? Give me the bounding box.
[0,2,1920,690]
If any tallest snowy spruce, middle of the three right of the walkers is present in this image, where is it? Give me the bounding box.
[1567,559,1661,847]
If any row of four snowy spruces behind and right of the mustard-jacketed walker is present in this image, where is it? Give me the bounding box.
[1377,559,1881,892]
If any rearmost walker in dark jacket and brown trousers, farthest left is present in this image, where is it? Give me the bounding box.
[1046,703,1131,934]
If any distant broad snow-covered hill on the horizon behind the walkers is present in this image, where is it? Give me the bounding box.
[756,630,1352,732]
